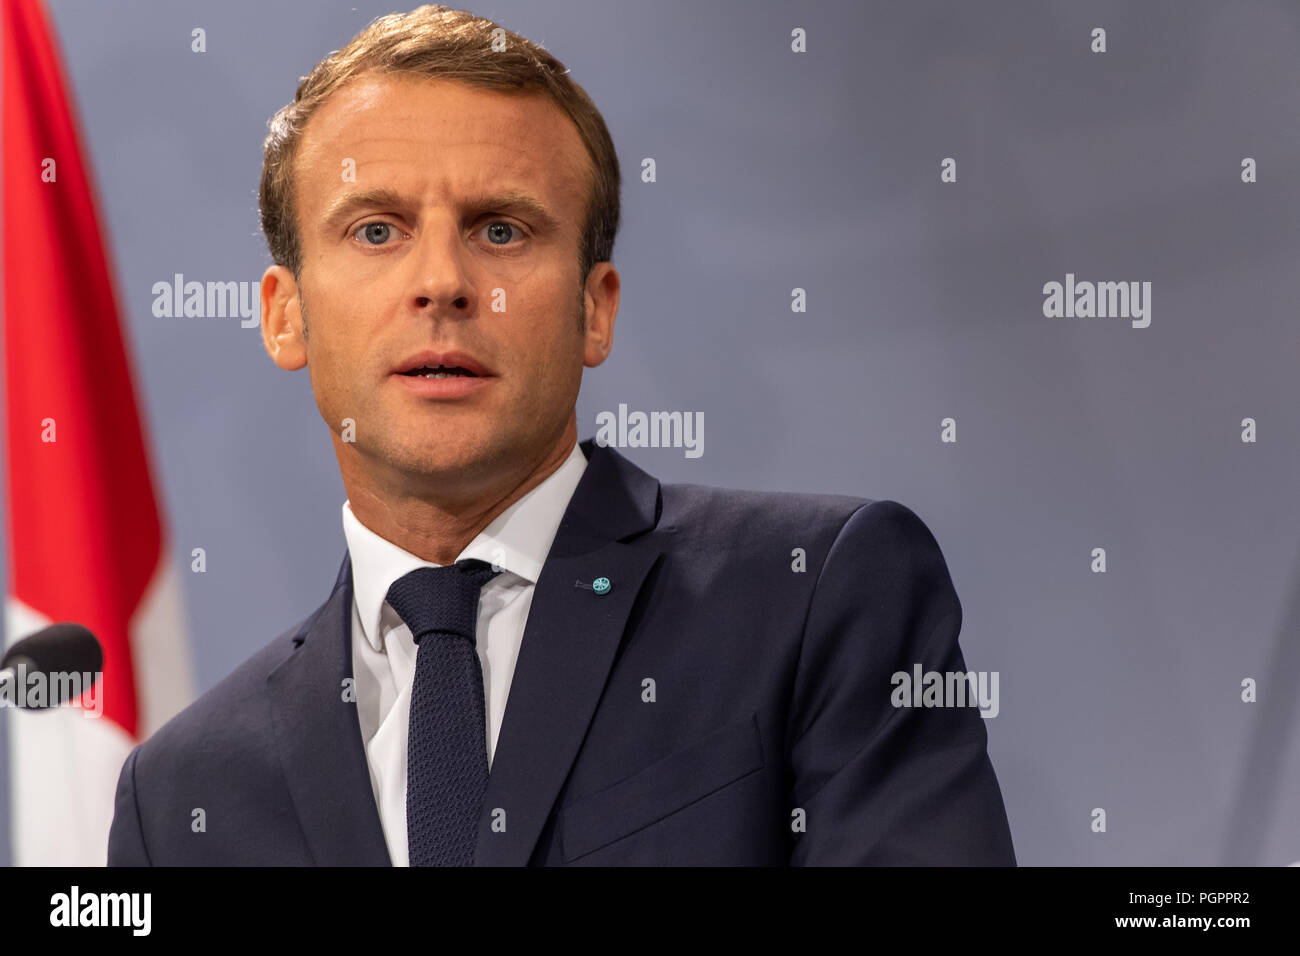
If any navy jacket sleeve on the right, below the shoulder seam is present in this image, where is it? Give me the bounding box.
[787,501,1015,866]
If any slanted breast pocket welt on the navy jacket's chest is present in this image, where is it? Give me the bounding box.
[558,714,763,862]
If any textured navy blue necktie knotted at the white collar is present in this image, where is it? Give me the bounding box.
[387,559,501,866]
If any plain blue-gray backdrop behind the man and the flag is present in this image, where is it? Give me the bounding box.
[0,0,1300,865]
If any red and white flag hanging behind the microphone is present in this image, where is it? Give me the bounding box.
[0,0,194,865]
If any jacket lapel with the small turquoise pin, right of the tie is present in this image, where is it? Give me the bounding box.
[475,440,660,866]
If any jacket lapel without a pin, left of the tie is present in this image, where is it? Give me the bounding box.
[267,555,390,866]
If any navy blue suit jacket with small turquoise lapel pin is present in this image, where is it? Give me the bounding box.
[108,440,1015,866]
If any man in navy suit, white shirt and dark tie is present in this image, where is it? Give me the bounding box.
[109,7,1014,865]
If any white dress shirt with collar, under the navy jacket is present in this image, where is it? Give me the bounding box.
[343,442,586,866]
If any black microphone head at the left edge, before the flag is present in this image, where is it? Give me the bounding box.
[0,622,104,710]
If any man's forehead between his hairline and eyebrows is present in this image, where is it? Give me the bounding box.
[294,73,590,222]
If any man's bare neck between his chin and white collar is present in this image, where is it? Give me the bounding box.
[343,420,577,564]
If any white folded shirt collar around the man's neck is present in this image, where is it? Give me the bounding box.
[343,442,586,650]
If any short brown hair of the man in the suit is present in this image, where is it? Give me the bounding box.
[259,5,620,281]
